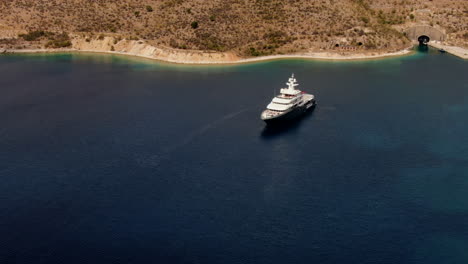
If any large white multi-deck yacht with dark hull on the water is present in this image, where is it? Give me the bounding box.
[261,74,316,124]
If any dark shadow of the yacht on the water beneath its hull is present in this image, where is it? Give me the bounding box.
[261,106,316,140]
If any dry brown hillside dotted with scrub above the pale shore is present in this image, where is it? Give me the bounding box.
[0,0,468,56]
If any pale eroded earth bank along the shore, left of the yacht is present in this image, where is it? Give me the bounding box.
[72,35,240,63]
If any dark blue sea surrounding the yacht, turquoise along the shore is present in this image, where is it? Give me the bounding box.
[0,50,468,264]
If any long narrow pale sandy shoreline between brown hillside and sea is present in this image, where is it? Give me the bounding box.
[0,38,468,65]
